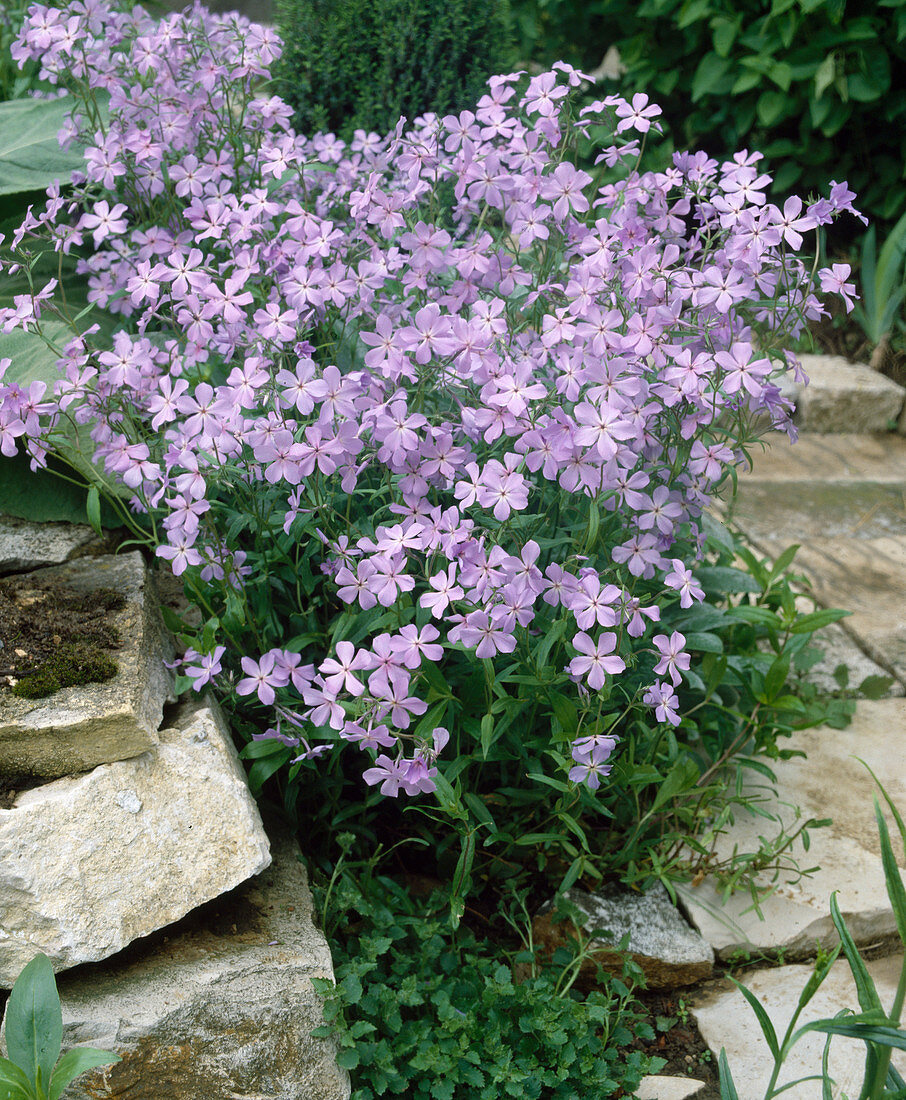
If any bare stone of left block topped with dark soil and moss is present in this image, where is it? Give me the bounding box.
[0,551,173,779]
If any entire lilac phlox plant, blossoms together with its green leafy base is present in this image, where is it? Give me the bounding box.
[0,0,870,1095]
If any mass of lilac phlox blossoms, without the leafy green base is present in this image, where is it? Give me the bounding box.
[0,0,854,796]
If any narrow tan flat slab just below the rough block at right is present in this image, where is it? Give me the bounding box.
[740,429,906,485]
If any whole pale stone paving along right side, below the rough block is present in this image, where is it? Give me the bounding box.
[672,422,906,1100]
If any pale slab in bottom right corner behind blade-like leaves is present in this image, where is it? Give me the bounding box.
[688,954,906,1100]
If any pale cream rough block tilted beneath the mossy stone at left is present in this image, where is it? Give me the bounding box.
[0,703,269,988]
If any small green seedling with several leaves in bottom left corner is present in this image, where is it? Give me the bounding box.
[0,955,120,1100]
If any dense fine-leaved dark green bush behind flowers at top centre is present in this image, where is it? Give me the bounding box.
[276,0,512,141]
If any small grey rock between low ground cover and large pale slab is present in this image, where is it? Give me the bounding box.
[533,884,714,989]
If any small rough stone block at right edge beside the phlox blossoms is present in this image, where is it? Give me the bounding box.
[794,355,906,432]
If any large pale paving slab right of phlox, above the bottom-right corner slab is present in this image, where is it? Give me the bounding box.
[676,699,906,960]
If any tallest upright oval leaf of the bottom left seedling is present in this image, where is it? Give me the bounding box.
[7,955,63,1084]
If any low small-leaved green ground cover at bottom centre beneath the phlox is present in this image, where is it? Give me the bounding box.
[314,872,660,1100]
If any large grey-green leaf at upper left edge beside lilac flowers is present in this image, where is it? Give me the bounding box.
[0,96,82,195]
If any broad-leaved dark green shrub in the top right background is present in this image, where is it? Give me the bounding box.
[512,0,906,229]
